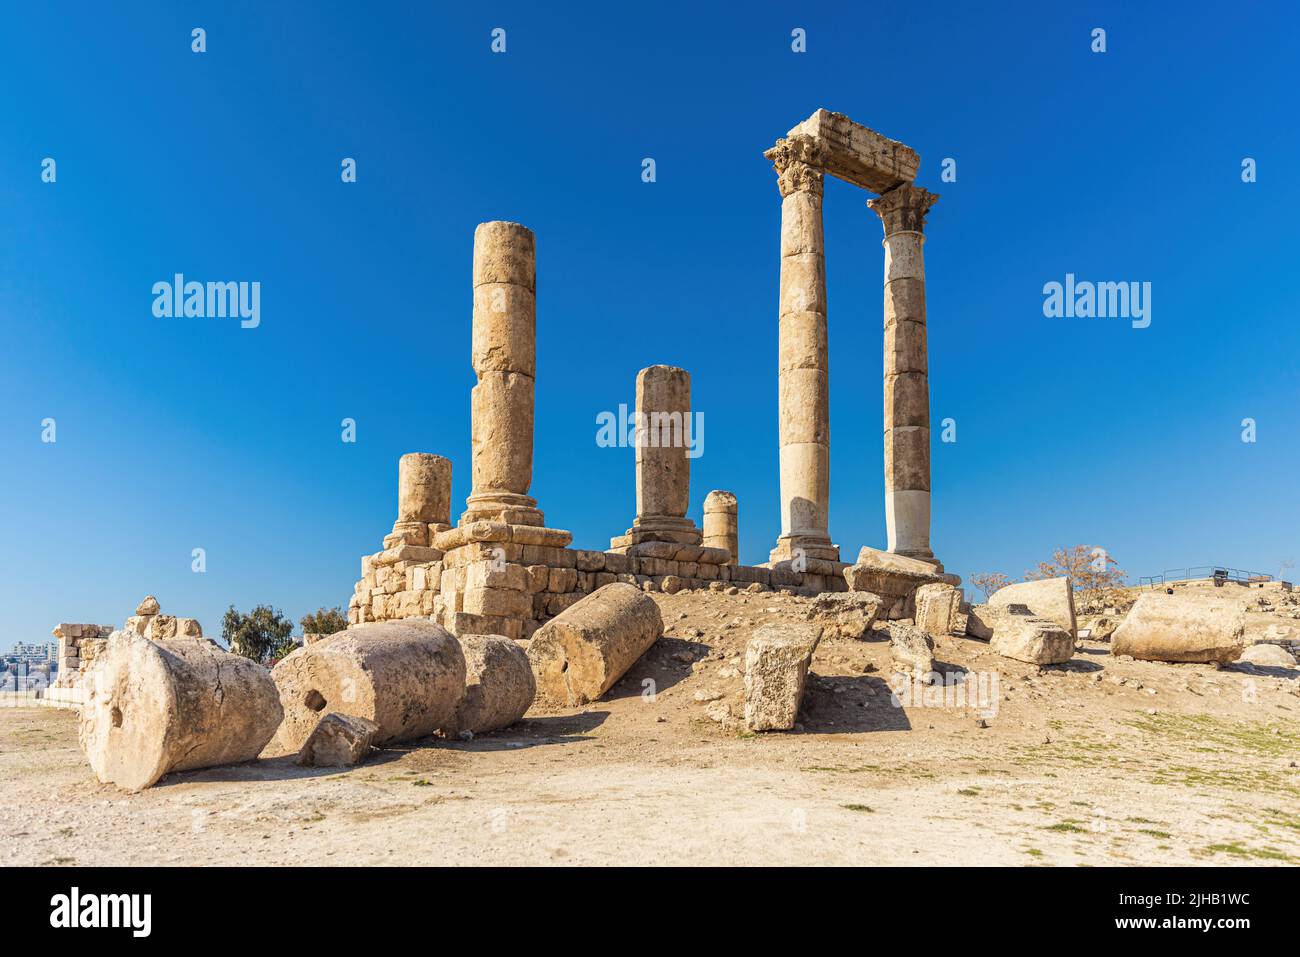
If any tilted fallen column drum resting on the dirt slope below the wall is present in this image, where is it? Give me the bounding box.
[528,583,663,706]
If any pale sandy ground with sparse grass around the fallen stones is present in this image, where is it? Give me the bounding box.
[0,593,1300,866]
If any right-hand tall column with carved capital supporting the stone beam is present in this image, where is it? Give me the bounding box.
[867,183,939,562]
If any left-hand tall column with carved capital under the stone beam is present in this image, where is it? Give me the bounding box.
[763,135,840,562]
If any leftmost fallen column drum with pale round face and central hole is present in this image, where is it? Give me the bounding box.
[78,632,282,791]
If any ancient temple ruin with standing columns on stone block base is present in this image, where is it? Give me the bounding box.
[348,111,959,650]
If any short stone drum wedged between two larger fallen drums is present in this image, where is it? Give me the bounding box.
[452,635,537,735]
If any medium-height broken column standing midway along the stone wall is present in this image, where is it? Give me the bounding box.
[610,365,699,549]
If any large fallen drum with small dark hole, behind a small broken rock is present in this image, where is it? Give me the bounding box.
[270,619,465,752]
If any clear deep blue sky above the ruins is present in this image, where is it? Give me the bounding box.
[0,3,1300,648]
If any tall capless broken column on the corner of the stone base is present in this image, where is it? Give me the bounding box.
[460,222,543,525]
